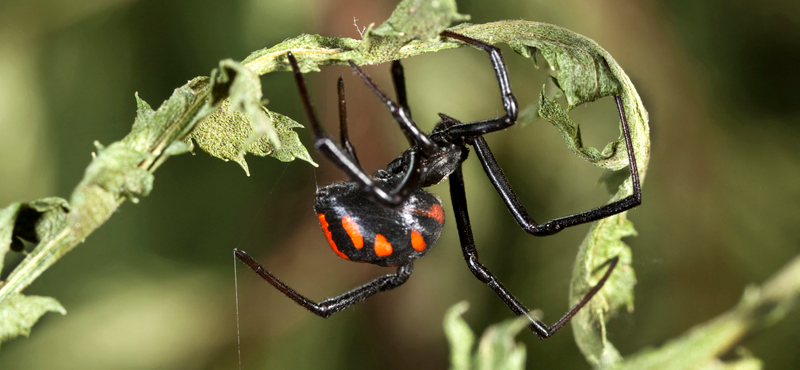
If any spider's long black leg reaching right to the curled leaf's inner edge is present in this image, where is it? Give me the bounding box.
[472,96,642,236]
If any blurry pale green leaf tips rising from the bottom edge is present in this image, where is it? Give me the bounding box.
[444,302,529,370]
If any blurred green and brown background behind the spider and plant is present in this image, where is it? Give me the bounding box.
[0,0,800,369]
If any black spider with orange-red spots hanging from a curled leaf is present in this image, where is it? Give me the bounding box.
[234,31,641,339]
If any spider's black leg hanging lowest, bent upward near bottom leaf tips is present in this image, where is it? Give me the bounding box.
[450,166,619,339]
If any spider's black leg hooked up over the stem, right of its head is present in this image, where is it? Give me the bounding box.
[440,31,519,142]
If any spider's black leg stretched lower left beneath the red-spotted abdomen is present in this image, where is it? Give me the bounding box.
[233,249,414,318]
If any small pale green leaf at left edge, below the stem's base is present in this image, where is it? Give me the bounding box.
[0,293,67,343]
